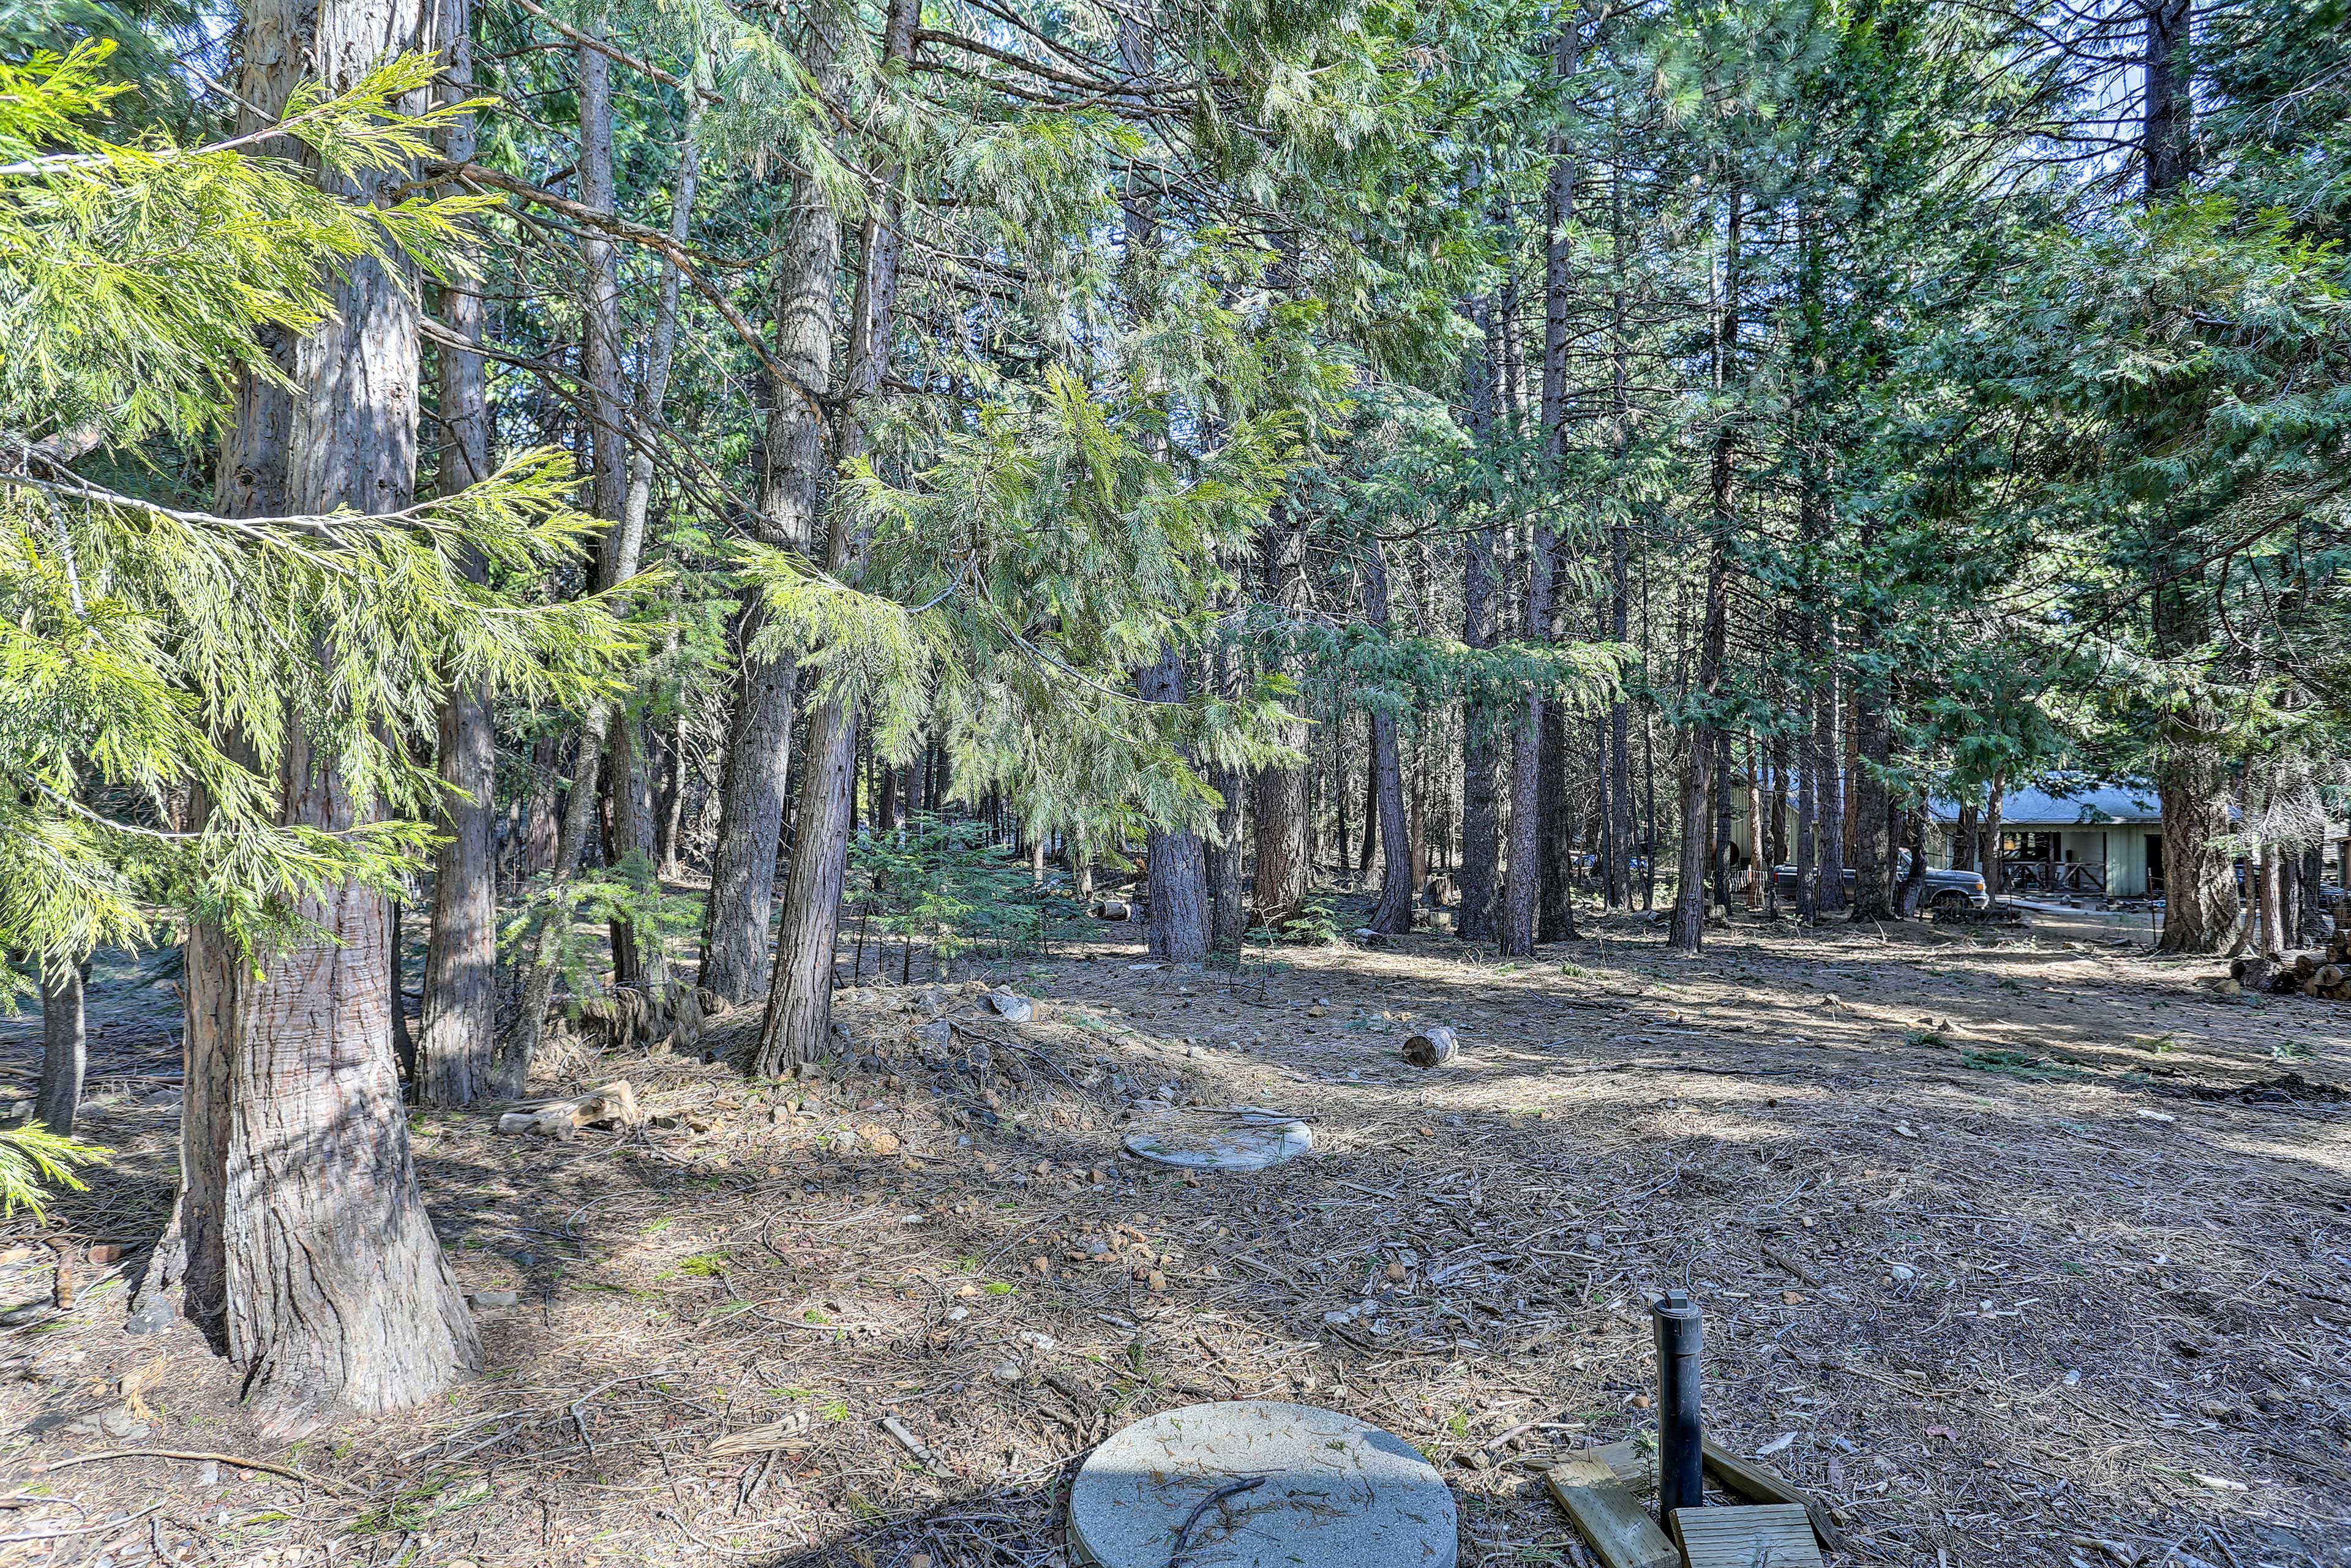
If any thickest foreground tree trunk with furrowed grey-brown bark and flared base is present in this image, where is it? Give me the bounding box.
[181,0,482,1441]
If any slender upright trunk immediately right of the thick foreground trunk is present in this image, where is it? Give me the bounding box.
[416,0,498,1105]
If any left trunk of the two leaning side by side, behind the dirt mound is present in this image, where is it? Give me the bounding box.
[700,21,842,1002]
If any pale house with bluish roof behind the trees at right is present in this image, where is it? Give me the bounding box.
[1928,778,2163,898]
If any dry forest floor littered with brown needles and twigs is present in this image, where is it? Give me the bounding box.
[0,919,2351,1568]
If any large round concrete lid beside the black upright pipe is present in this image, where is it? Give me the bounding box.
[1070,1401,1458,1568]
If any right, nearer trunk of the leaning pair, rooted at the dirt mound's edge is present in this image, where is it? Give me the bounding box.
[759,0,921,1077]
